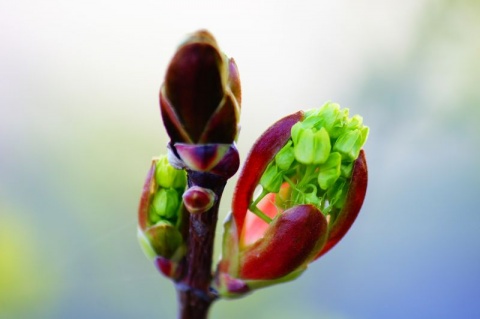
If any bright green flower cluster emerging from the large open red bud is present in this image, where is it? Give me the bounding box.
[258,102,369,220]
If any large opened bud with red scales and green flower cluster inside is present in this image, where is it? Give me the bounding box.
[216,103,368,297]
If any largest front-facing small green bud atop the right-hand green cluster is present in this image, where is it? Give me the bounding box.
[294,127,331,164]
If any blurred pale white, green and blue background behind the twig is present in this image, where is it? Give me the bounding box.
[0,0,480,319]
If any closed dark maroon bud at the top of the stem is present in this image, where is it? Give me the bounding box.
[160,31,241,144]
